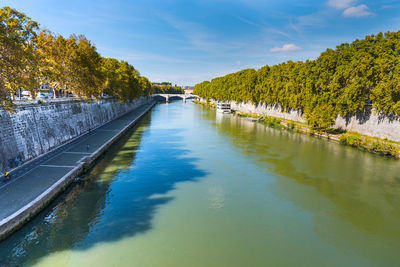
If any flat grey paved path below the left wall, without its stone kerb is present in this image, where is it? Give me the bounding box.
[0,104,150,221]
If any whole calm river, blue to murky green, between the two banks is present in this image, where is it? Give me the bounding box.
[0,101,400,267]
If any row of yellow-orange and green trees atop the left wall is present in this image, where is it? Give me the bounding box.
[0,7,152,110]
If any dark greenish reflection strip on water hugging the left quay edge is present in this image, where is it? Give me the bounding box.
[0,117,149,266]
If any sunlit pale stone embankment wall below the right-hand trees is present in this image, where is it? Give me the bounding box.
[200,98,400,141]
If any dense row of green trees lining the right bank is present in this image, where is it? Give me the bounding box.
[193,31,400,131]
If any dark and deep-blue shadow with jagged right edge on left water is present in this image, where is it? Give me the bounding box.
[0,112,205,266]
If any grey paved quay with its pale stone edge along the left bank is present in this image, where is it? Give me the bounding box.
[0,102,155,242]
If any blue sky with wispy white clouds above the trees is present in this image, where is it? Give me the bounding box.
[0,0,400,86]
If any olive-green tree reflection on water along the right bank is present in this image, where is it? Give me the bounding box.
[199,103,400,255]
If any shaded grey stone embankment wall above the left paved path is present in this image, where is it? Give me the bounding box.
[0,97,151,171]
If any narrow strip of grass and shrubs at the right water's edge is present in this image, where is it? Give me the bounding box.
[193,101,400,159]
